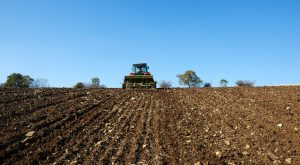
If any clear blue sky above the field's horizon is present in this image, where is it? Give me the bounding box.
[0,0,300,87]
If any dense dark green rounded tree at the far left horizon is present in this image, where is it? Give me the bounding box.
[4,73,34,88]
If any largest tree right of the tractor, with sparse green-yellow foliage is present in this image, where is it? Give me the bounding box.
[177,70,203,88]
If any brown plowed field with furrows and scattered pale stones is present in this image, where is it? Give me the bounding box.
[0,86,300,165]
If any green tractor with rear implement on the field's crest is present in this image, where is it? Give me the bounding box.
[122,63,156,89]
